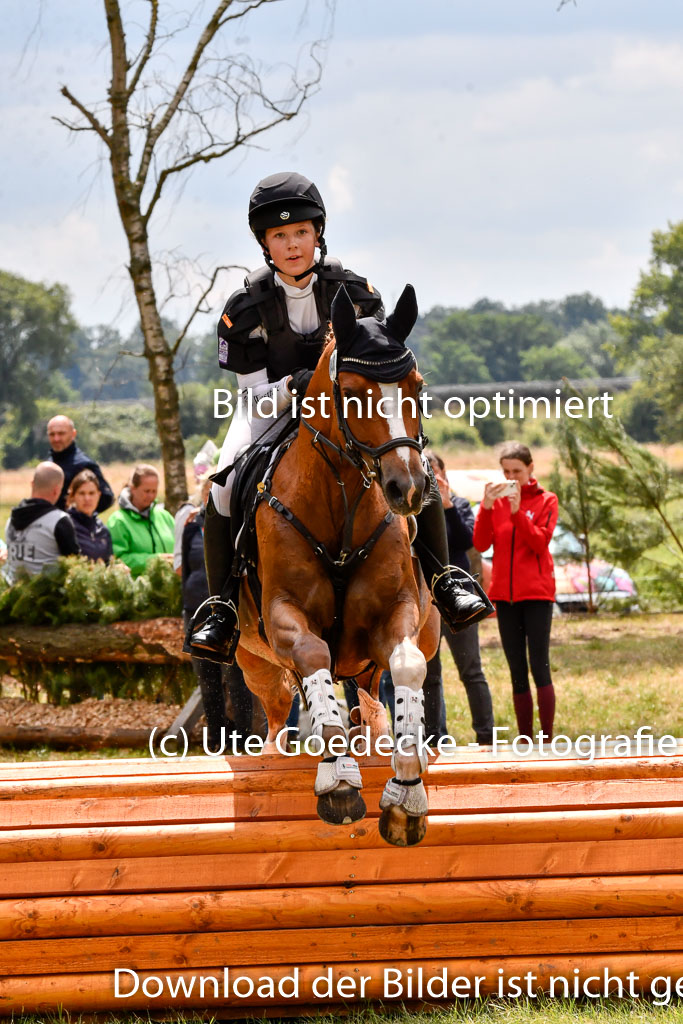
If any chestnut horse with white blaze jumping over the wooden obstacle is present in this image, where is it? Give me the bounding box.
[237,285,439,846]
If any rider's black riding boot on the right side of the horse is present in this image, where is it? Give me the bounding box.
[415,469,494,633]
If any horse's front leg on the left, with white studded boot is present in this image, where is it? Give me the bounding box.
[266,599,366,824]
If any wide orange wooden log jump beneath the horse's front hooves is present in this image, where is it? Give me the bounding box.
[0,749,683,1018]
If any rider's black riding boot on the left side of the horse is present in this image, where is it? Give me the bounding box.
[187,498,238,662]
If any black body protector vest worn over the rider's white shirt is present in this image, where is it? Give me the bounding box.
[218,256,384,381]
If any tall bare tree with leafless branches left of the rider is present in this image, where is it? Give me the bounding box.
[55,0,333,510]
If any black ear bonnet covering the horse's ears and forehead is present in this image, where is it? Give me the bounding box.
[330,285,418,384]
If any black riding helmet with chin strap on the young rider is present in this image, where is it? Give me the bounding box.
[249,171,327,280]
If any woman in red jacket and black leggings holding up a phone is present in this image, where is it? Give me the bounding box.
[473,441,557,736]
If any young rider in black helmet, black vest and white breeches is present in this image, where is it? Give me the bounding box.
[190,172,483,656]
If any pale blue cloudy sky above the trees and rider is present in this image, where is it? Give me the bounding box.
[0,0,683,329]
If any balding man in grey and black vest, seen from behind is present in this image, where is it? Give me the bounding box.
[3,462,79,584]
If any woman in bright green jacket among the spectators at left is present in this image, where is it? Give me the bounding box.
[106,464,174,577]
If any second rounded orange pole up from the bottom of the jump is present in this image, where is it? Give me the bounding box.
[0,874,683,940]
